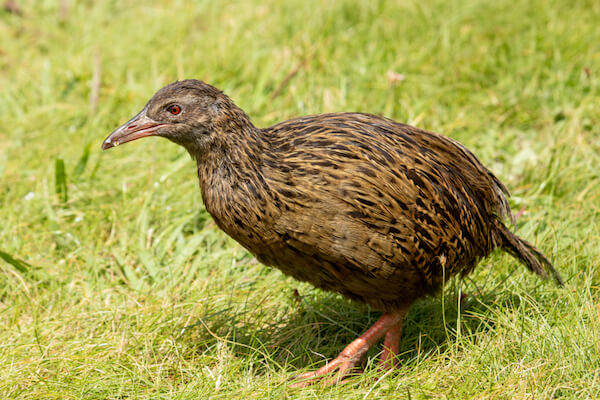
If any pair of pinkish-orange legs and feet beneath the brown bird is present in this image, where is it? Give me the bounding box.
[291,307,408,387]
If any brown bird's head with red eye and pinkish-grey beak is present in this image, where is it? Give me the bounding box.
[102,80,249,158]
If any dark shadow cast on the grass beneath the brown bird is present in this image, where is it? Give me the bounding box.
[179,286,520,375]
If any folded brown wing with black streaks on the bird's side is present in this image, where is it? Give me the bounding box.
[266,114,506,277]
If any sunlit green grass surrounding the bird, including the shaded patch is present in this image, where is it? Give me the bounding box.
[0,0,600,399]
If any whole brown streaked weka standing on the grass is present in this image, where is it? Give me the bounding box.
[102,80,561,386]
